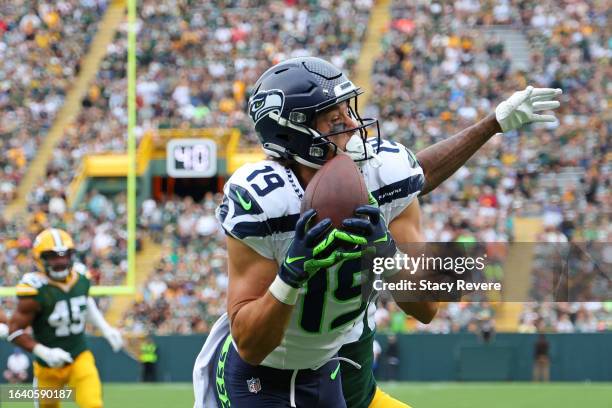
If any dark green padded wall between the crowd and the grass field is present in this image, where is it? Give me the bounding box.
[0,332,612,382]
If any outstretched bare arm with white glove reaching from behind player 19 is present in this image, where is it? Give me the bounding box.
[416,86,562,195]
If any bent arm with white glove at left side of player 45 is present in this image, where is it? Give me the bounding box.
[7,297,72,367]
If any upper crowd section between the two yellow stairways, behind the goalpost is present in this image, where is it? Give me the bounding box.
[47,0,372,183]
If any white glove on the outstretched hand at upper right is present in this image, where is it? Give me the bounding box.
[495,86,563,132]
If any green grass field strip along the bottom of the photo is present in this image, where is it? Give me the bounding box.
[0,383,612,408]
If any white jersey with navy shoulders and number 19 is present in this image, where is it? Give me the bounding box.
[217,141,424,369]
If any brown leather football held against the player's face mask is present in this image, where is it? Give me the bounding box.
[302,154,368,227]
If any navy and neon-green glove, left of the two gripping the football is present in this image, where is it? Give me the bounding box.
[278,209,368,289]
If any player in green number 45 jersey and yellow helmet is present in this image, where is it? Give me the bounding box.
[7,228,123,408]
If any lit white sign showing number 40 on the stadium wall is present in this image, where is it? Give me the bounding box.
[166,139,217,178]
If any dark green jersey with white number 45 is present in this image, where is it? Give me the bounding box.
[17,267,91,366]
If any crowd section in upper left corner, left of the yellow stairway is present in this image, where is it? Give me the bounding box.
[0,0,106,211]
